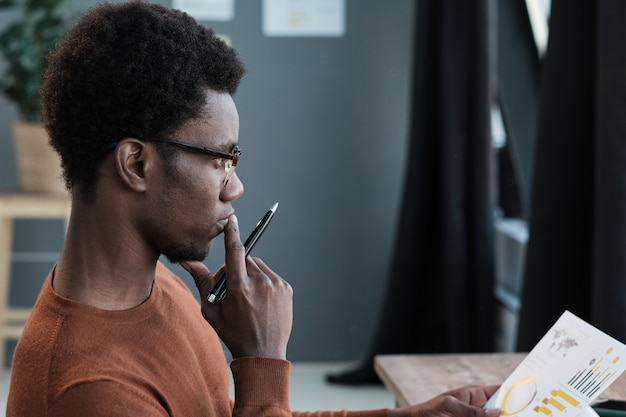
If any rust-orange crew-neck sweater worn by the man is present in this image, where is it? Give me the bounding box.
[6,263,387,417]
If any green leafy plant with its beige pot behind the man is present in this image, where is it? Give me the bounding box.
[0,0,67,193]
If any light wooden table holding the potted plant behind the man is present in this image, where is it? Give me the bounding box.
[0,193,71,372]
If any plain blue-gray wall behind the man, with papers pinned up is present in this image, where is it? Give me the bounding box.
[0,0,415,361]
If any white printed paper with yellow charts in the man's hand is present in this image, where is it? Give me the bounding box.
[485,311,626,417]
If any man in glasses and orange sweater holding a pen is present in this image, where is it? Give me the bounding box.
[7,2,499,417]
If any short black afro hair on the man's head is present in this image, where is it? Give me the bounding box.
[41,1,245,194]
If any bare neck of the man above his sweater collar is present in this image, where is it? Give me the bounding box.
[53,192,158,310]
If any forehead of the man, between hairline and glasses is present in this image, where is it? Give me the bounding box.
[175,90,239,150]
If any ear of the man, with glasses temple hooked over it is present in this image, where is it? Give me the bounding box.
[114,138,154,193]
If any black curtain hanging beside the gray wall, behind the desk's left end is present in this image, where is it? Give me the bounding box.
[329,0,495,383]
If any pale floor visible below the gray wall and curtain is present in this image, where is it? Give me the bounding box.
[0,363,394,417]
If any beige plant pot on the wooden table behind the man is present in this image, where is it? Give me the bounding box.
[13,122,67,195]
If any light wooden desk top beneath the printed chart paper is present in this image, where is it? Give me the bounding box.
[374,353,626,407]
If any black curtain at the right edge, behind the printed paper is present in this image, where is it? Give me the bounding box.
[517,0,626,351]
